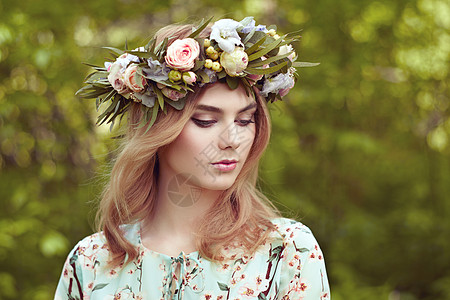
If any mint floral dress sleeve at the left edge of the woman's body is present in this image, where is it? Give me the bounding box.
[54,243,83,300]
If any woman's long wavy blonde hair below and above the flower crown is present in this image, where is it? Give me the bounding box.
[97,25,279,266]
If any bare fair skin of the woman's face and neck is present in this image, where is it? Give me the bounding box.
[141,83,256,256]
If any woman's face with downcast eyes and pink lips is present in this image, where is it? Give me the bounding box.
[158,83,256,190]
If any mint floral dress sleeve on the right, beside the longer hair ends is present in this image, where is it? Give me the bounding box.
[278,222,330,300]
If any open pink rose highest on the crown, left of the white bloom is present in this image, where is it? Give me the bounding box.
[165,38,200,72]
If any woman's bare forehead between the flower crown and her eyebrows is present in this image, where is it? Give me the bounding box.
[197,83,256,111]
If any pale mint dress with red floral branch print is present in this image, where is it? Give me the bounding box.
[55,218,330,300]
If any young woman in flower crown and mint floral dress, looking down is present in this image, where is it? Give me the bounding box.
[55,18,330,299]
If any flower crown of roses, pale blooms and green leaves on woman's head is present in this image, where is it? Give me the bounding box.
[76,17,317,130]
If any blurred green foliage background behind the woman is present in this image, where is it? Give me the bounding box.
[0,0,450,300]
